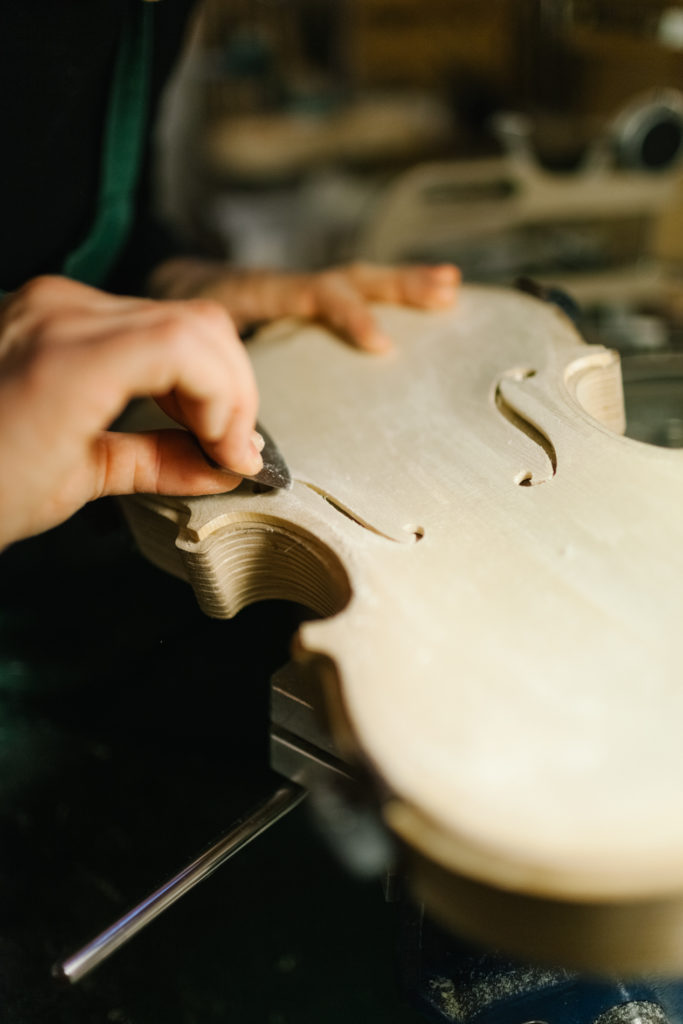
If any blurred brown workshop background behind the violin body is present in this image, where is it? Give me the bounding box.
[158,0,683,445]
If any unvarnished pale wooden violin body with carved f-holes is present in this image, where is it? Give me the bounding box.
[120,287,683,973]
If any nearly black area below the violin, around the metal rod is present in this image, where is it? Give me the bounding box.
[0,501,422,1024]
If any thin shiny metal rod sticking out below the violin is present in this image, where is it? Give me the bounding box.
[52,783,306,982]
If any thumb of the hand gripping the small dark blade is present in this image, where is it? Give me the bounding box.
[92,430,242,499]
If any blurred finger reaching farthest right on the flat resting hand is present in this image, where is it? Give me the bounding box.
[348,263,461,309]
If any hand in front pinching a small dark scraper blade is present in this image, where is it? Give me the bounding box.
[0,276,262,548]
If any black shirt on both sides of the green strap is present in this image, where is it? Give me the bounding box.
[0,0,195,292]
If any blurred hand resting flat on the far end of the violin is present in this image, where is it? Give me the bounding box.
[151,259,460,352]
